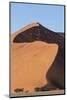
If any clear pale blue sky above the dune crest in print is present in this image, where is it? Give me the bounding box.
[11,3,64,33]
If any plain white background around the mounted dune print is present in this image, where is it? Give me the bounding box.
[0,0,67,100]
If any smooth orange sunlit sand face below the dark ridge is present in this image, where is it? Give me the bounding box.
[11,41,58,93]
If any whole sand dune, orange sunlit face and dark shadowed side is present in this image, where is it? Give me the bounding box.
[11,23,64,93]
